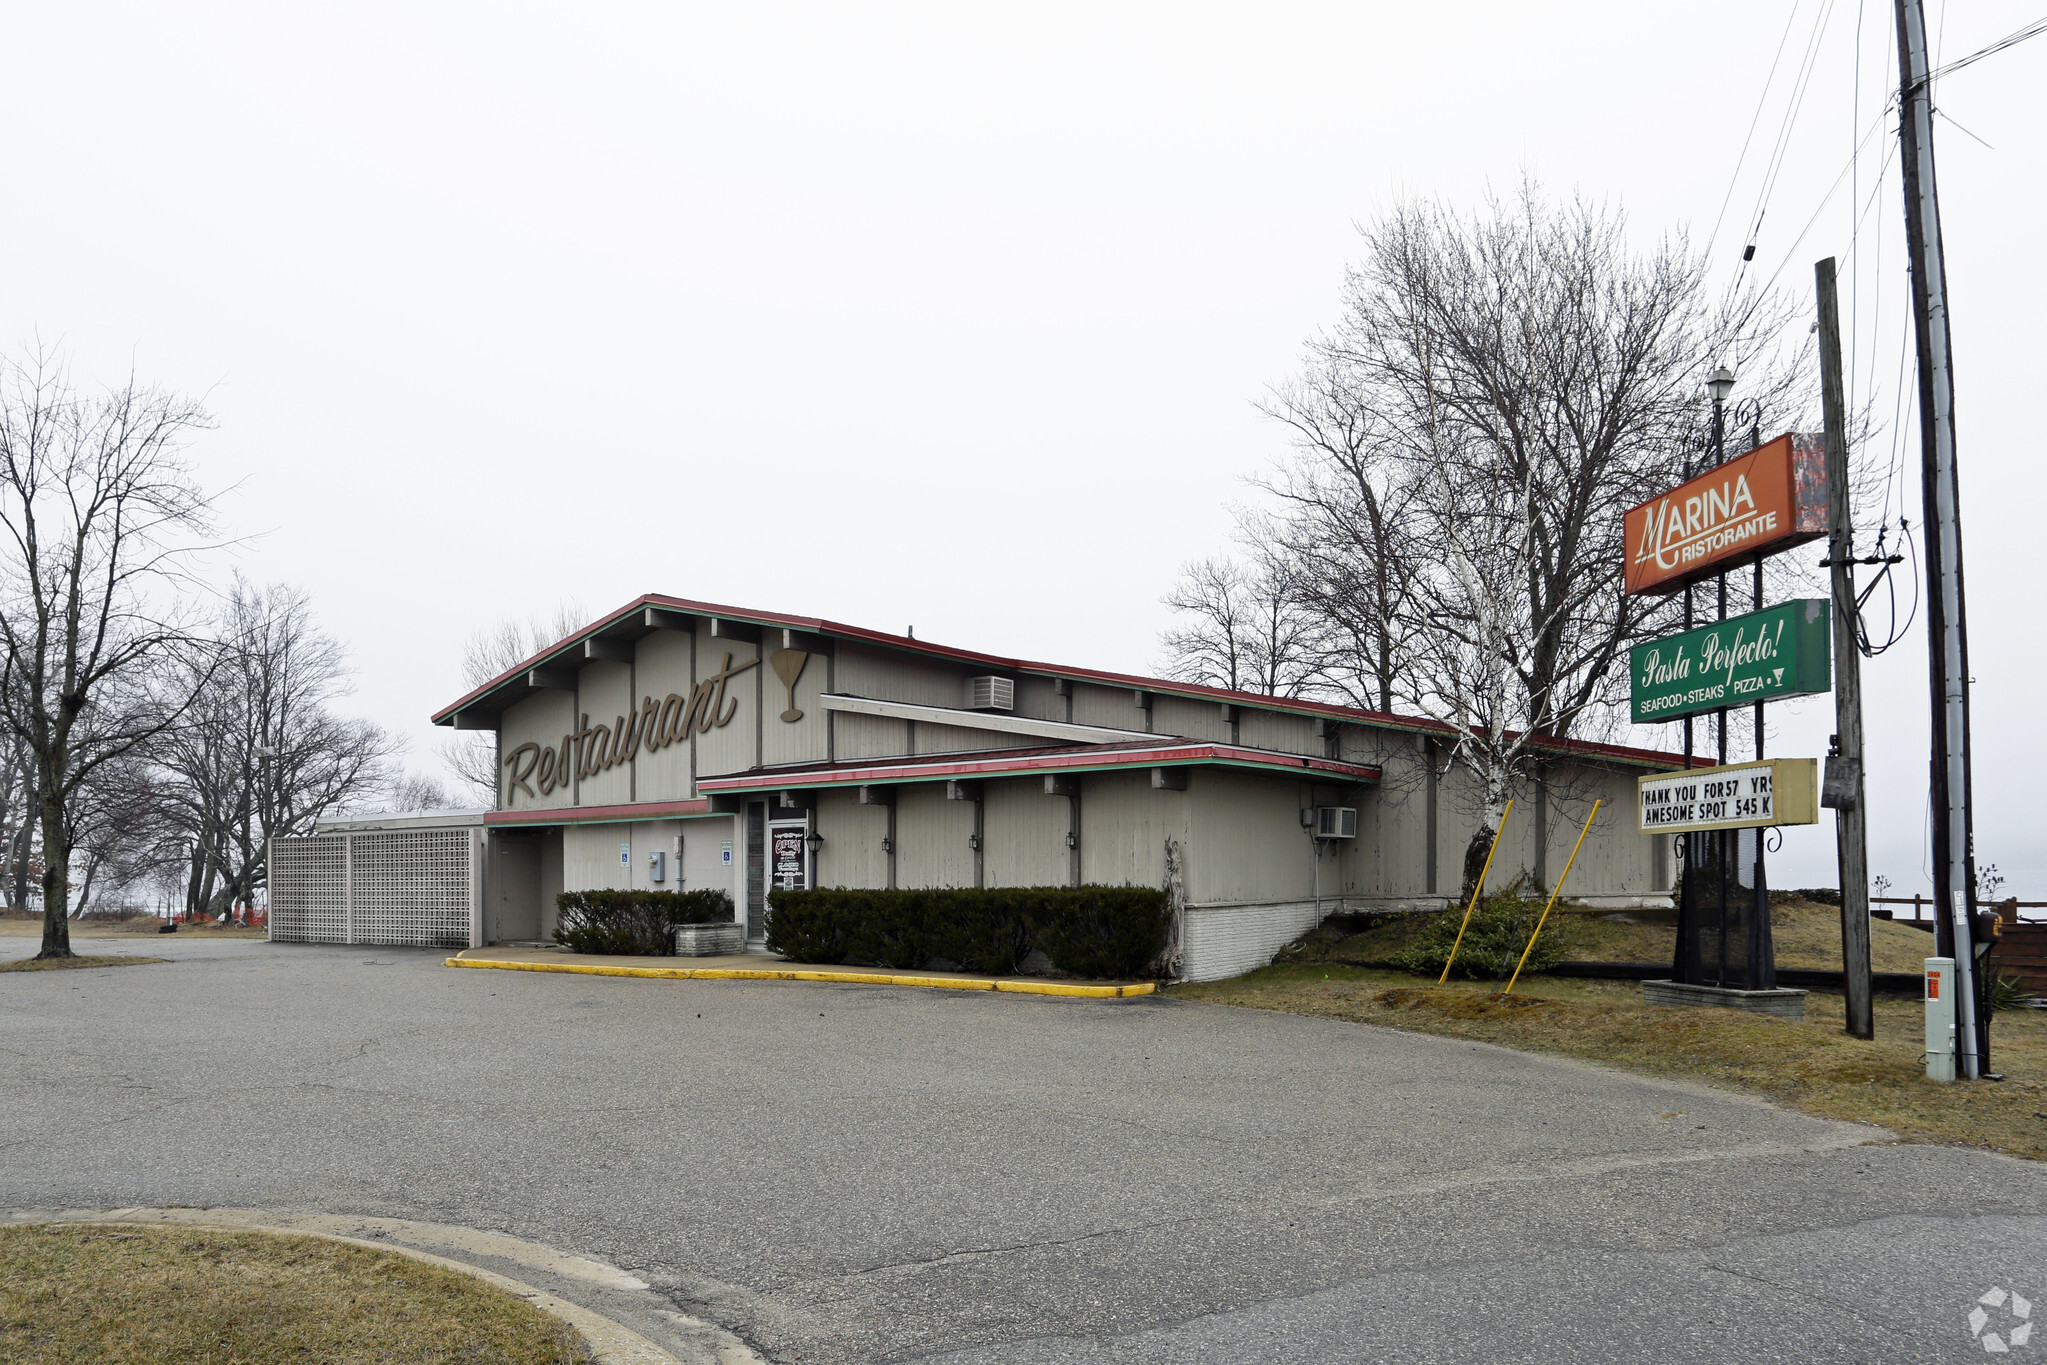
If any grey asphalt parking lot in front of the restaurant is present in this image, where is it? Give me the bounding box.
[0,939,2047,1365]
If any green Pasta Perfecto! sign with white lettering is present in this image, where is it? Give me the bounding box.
[1627,598,1834,724]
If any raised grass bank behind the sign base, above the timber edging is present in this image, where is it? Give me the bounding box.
[1286,900,1932,970]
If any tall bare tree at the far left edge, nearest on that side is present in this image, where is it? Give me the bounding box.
[0,354,211,958]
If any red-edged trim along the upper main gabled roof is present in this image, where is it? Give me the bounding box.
[432,593,1697,767]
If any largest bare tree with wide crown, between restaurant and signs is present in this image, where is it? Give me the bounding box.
[1220,186,1799,892]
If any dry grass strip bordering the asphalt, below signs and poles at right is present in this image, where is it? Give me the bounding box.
[1169,961,2047,1160]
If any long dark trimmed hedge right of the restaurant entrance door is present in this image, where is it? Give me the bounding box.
[768,886,1169,978]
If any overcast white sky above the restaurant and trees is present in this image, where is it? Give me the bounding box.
[0,0,2047,898]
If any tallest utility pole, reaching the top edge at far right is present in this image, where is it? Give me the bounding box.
[1891,0,1990,1081]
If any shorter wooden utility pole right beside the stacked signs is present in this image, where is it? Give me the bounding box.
[1825,256,1877,1038]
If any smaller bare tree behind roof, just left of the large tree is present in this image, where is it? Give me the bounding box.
[1161,544,1322,696]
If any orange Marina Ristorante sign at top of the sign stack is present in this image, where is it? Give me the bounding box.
[1621,436,1826,593]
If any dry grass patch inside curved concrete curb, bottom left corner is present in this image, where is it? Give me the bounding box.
[0,1224,592,1365]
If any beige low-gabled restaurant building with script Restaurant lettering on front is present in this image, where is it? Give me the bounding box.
[285,596,1681,980]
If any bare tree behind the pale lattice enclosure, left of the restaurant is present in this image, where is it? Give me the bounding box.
[156,575,399,915]
